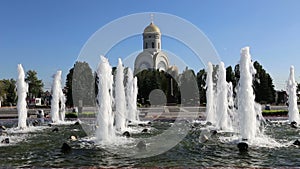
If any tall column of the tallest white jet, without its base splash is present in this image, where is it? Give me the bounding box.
[237,47,257,141]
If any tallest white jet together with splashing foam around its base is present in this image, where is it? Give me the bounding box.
[220,47,280,147]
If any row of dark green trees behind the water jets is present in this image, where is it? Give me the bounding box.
[0,61,292,107]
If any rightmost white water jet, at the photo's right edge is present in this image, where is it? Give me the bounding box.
[287,66,299,125]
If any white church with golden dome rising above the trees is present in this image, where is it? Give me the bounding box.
[134,21,178,74]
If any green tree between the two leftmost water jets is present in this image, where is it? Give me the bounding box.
[25,70,44,98]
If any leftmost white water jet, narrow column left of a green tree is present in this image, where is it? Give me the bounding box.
[17,64,28,129]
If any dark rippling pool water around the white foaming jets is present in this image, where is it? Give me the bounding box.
[0,121,300,168]
